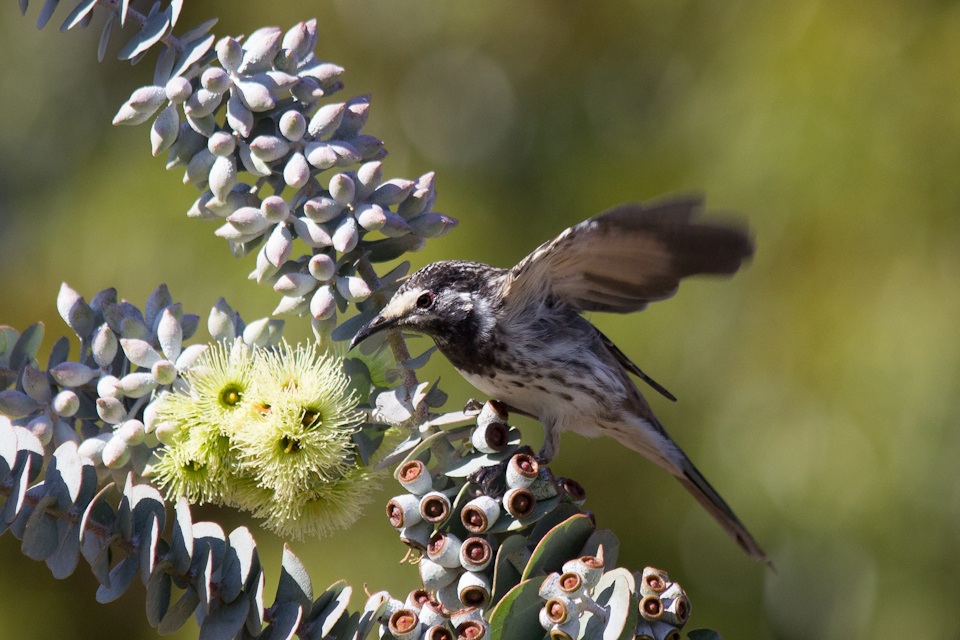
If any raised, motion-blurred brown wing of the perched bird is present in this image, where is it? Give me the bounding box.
[504,195,753,313]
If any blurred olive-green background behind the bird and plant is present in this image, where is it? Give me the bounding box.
[0,0,960,640]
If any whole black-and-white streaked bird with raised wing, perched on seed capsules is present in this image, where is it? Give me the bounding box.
[350,194,772,567]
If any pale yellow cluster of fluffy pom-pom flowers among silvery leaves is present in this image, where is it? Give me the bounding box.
[152,340,375,538]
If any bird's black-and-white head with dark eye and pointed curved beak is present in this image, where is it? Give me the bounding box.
[350,261,502,349]
